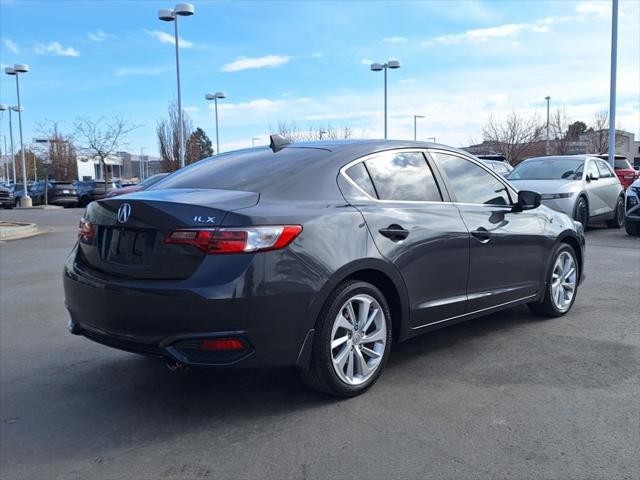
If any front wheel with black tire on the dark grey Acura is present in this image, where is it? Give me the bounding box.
[527,243,580,318]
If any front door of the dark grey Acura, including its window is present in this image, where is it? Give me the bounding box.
[429,150,550,313]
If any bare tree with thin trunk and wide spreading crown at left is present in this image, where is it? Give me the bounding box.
[75,117,137,194]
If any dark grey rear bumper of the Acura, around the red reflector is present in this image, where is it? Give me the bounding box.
[63,248,323,367]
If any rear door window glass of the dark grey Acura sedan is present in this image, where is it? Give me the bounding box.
[364,152,442,202]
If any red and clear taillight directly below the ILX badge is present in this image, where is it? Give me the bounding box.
[164,225,302,254]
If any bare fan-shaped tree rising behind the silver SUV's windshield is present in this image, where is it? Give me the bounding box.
[482,112,544,165]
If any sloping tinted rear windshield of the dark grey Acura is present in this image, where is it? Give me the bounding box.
[149,148,330,193]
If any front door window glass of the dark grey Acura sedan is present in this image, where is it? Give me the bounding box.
[432,152,511,205]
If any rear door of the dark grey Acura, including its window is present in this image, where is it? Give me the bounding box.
[342,150,469,328]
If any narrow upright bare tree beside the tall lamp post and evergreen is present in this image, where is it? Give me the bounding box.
[156,102,192,172]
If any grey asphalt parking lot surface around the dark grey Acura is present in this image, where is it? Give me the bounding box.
[0,209,640,479]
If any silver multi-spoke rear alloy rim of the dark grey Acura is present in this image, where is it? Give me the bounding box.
[331,294,387,385]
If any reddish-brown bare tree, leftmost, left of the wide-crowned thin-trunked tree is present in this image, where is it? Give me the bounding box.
[37,122,78,182]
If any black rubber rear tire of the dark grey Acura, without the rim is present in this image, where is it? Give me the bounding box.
[314,281,392,397]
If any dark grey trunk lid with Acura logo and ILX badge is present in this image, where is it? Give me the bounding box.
[79,189,259,279]
